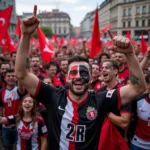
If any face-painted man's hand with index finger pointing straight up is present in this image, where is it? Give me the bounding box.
[21,5,39,35]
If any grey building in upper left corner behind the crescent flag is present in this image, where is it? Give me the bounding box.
[0,0,17,35]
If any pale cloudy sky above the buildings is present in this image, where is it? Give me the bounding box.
[16,0,104,26]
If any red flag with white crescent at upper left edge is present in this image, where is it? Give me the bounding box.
[0,6,13,44]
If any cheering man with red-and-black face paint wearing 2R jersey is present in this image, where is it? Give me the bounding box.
[15,6,146,150]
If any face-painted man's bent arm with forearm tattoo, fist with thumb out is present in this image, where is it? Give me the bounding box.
[108,31,146,105]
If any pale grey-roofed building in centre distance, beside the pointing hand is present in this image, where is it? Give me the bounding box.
[37,9,72,36]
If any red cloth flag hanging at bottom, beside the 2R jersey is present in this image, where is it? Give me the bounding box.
[98,118,129,150]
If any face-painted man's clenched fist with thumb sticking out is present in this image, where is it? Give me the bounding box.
[108,30,133,54]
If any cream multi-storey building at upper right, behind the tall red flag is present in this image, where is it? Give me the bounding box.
[82,0,150,42]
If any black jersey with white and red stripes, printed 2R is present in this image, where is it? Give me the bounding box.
[34,81,120,150]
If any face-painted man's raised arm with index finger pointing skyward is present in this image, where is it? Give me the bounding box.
[15,6,39,95]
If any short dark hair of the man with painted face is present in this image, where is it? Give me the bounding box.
[68,55,89,65]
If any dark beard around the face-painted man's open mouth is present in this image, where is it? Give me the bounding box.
[68,79,89,96]
